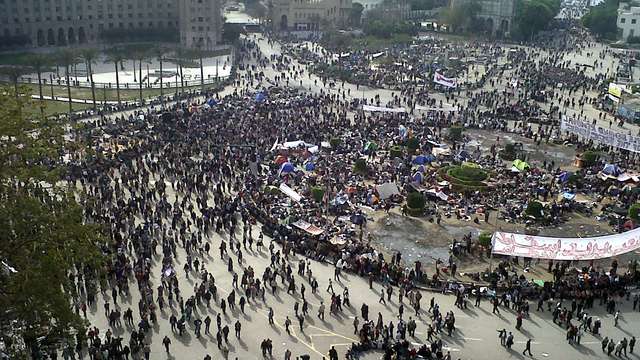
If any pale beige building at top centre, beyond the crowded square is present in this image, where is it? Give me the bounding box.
[269,0,352,31]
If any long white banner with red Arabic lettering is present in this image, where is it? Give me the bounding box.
[491,228,640,260]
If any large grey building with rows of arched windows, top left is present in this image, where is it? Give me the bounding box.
[0,0,222,47]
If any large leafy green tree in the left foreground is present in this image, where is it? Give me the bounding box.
[0,84,103,359]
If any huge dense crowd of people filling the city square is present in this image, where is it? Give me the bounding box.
[31,15,638,360]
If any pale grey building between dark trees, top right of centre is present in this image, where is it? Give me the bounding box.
[450,0,516,37]
